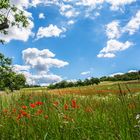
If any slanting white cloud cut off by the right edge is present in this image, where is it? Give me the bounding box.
[123,10,140,35]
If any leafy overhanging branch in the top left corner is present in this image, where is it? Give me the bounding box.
[0,0,29,43]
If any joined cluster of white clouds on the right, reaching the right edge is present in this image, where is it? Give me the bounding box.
[97,8,140,58]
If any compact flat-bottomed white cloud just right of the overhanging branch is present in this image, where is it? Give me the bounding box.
[37,24,65,39]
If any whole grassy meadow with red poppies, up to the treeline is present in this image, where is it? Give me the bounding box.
[0,81,140,140]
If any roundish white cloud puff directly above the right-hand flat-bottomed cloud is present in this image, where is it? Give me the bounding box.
[106,21,121,39]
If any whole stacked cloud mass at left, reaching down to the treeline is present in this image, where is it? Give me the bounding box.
[13,48,69,85]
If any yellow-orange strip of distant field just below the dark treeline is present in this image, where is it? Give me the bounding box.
[22,81,140,95]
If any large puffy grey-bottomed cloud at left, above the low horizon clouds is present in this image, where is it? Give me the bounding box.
[22,48,68,72]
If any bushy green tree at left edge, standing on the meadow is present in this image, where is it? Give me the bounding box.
[0,53,26,91]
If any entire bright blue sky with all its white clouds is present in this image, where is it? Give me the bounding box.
[0,0,140,85]
